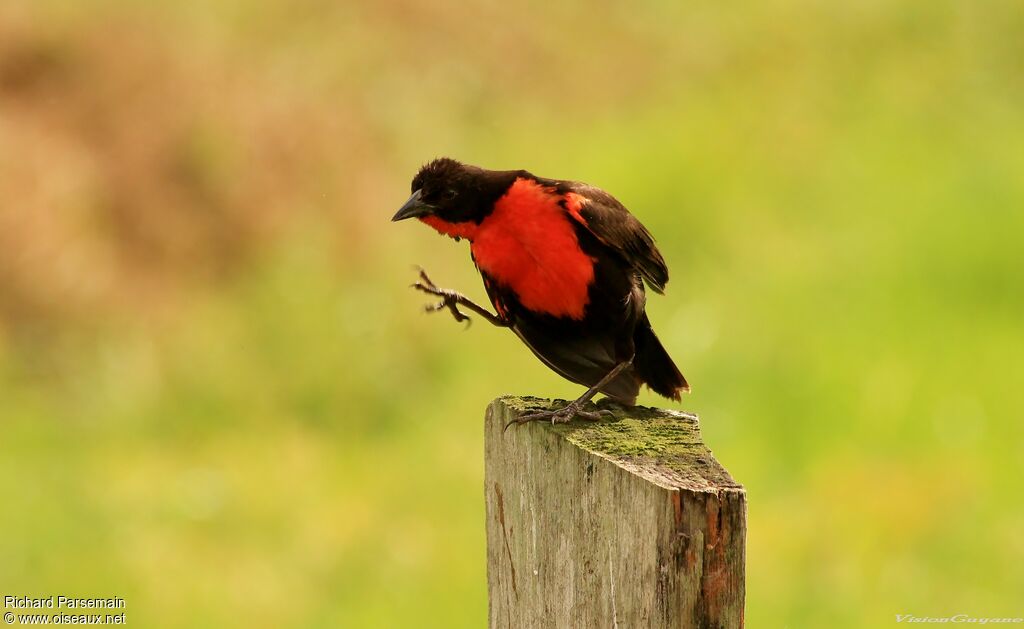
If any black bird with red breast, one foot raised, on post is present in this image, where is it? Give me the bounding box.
[391,158,690,428]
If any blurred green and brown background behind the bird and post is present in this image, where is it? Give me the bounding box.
[0,0,1024,628]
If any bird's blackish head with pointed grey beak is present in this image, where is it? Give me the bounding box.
[391,158,516,223]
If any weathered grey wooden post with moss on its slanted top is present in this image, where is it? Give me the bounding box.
[485,396,746,629]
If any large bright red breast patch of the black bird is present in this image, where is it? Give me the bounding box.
[471,177,594,319]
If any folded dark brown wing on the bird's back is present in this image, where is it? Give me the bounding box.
[563,182,669,293]
